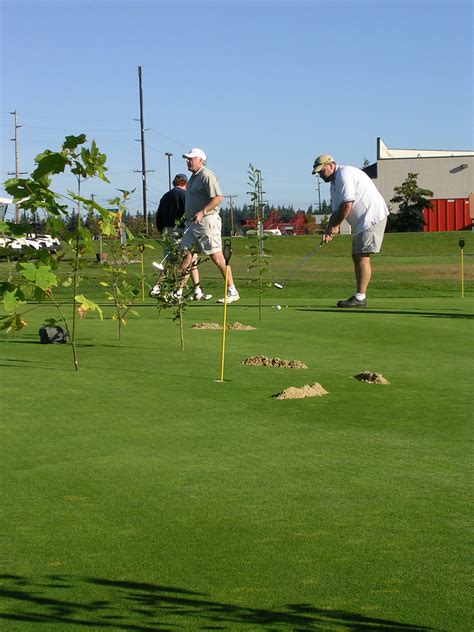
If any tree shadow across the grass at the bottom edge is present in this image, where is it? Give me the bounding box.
[0,575,433,632]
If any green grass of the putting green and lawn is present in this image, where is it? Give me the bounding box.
[0,234,474,632]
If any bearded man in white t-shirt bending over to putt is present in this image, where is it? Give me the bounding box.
[313,154,389,307]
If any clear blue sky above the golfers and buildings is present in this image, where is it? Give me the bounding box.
[0,0,474,212]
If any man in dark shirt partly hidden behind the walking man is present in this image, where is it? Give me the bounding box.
[150,173,212,301]
